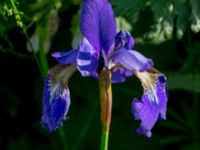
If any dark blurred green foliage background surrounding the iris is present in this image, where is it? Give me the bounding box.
[0,0,200,150]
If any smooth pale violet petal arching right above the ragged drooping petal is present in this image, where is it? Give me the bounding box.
[109,49,153,72]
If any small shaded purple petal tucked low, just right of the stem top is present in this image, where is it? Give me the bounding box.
[111,68,133,83]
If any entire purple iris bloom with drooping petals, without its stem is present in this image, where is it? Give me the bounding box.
[42,0,167,137]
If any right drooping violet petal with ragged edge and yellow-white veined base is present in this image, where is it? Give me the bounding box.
[132,68,167,137]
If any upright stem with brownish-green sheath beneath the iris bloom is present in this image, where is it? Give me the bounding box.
[99,69,112,150]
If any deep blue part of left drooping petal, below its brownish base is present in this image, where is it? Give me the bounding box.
[42,75,70,132]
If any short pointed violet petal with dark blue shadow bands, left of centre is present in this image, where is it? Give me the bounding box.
[77,38,99,76]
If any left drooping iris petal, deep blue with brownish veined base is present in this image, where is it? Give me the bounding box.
[41,65,75,132]
